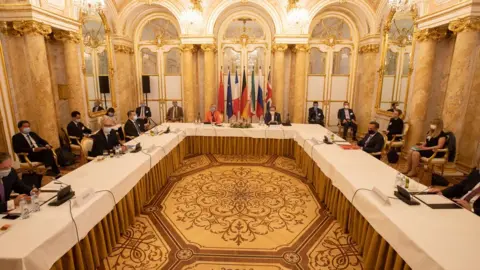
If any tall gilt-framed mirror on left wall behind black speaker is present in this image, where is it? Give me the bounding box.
[81,13,116,117]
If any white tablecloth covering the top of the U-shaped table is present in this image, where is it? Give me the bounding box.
[0,123,480,270]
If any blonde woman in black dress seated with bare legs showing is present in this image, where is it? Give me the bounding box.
[404,119,447,177]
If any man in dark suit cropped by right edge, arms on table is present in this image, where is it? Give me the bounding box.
[429,158,480,216]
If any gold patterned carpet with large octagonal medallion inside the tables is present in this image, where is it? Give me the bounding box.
[102,155,363,270]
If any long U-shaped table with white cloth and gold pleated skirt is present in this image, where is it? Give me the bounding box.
[0,123,480,270]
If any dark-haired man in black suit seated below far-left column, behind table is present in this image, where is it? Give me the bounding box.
[12,120,60,176]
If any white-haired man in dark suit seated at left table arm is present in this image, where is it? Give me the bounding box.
[89,118,125,157]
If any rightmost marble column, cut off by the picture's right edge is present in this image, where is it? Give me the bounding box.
[442,17,480,167]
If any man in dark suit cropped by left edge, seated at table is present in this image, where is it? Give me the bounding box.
[0,152,39,213]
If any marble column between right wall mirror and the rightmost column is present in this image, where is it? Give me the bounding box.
[405,28,446,149]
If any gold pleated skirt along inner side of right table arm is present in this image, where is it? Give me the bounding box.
[295,145,411,270]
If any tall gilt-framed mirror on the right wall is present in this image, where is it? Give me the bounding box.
[376,10,416,115]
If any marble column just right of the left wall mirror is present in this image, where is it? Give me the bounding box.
[113,45,138,122]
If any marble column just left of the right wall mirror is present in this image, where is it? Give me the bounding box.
[355,44,380,134]
